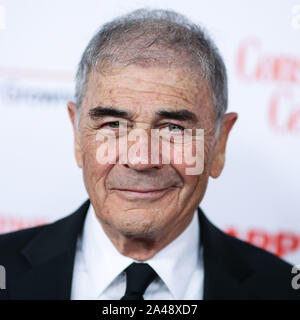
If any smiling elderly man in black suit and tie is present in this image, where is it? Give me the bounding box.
[0,10,299,300]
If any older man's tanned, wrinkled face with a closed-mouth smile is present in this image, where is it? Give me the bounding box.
[69,66,237,239]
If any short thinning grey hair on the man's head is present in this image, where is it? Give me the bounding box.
[75,9,228,135]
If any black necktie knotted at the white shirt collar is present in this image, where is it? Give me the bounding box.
[120,262,157,300]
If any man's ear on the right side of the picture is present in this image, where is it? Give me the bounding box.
[209,112,238,178]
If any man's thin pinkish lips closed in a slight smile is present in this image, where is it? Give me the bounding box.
[113,187,174,200]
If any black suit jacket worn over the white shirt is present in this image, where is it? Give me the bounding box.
[0,200,300,300]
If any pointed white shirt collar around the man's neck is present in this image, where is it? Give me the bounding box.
[82,204,200,299]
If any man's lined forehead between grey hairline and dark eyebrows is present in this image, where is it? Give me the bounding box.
[83,65,213,122]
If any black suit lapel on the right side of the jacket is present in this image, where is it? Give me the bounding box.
[198,208,255,300]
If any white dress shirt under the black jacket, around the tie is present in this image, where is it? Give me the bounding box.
[71,204,204,300]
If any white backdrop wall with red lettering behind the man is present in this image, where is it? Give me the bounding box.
[0,0,300,264]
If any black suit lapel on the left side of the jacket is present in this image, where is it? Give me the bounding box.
[9,200,90,300]
